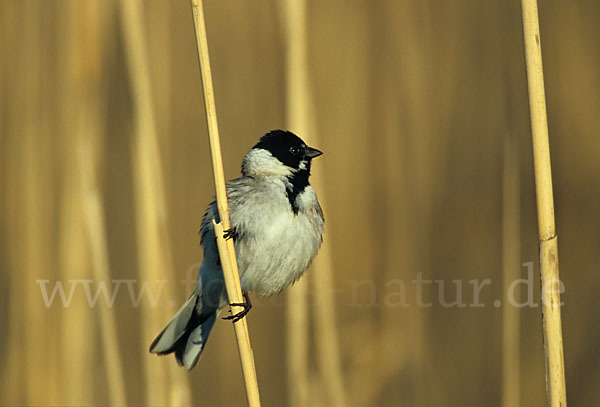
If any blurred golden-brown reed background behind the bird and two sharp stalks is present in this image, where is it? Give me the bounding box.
[0,0,600,406]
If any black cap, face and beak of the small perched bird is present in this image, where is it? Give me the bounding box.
[254,130,323,169]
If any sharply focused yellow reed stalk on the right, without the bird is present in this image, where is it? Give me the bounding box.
[521,0,567,407]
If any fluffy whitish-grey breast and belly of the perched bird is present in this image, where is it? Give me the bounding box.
[231,180,323,295]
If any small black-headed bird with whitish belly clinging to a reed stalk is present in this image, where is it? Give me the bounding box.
[150,130,324,370]
